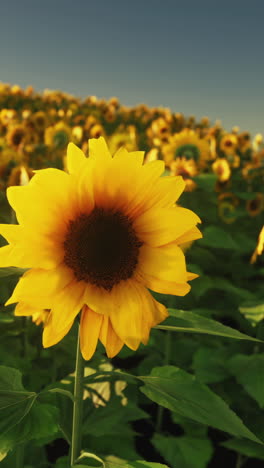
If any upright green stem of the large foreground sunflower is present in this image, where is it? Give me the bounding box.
[71,327,84,466]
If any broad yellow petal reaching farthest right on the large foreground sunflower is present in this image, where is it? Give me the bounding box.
[133,206,200,247]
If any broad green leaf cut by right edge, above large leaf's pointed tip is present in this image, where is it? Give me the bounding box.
[228,354,264,408]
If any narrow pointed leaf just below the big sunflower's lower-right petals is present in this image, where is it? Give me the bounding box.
[155,309,260,341]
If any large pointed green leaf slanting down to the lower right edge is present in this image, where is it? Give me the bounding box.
[139,366,261,443]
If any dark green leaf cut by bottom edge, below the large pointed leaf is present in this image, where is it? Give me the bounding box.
[151,434,213,468]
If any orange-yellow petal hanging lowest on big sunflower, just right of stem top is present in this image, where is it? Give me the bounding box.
[80,306,103,360]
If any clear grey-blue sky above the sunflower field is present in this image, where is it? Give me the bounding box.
[0,0,264,133]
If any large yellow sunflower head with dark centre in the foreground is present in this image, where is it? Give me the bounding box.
[0,137,201,359]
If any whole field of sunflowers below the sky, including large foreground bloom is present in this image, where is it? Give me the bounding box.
[0,83,264,468]
